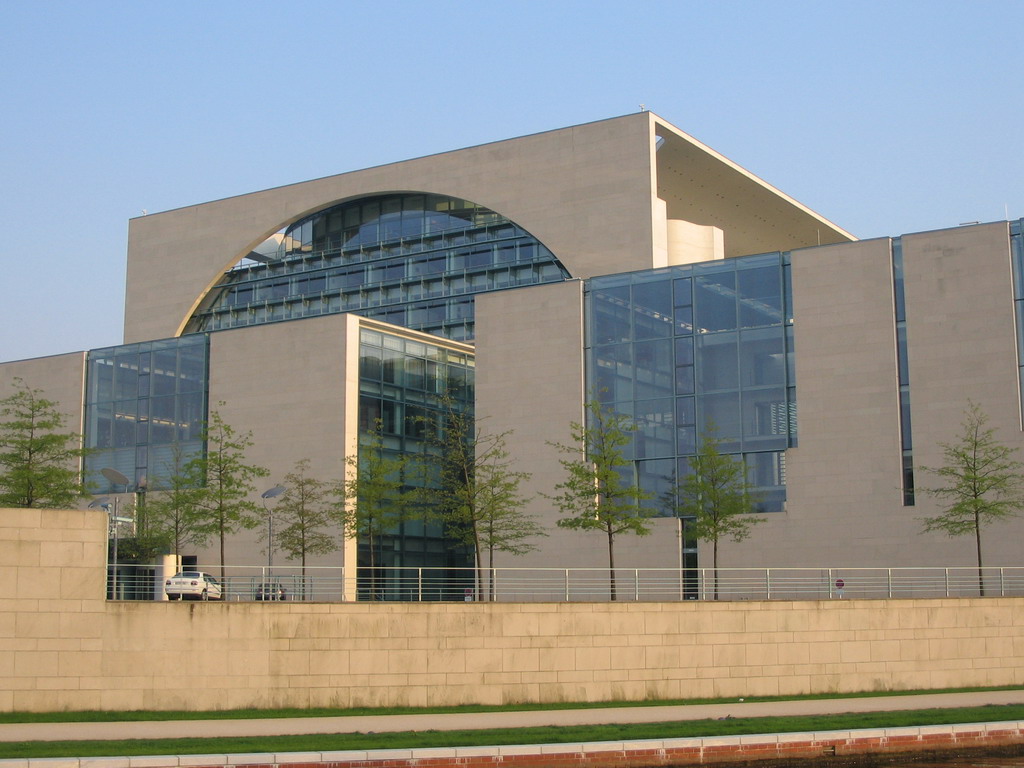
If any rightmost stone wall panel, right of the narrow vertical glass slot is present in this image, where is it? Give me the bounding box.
[902,222,1024,565]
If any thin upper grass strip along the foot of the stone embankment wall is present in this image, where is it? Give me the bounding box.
[0,685,1024,723]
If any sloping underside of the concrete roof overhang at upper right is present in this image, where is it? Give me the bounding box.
[654,118,857,257]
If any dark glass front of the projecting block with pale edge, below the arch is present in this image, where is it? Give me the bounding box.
[358,329,474,600]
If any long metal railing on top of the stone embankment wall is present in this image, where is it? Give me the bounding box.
[108,564,1024,602]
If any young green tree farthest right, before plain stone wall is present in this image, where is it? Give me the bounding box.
[918,401,1024,597]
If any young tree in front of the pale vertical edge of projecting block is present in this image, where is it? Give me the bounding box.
[335,420,411,600]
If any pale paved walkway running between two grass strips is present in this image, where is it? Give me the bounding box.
[8,689,1024,741]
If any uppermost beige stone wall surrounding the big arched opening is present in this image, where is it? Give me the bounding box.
[125,113,664,342]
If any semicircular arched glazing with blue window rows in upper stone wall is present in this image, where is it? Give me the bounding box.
[185,194,570,341]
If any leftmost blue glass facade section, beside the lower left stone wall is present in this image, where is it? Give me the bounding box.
[85,334,209,493]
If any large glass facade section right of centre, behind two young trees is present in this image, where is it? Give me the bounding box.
[586,253,797,514]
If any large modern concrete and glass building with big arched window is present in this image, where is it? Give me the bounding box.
[0,112,1024,593]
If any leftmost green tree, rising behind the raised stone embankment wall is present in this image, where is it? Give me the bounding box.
[0,378,87,509]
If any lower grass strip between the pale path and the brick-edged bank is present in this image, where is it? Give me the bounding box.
[6,705,1024,759]
